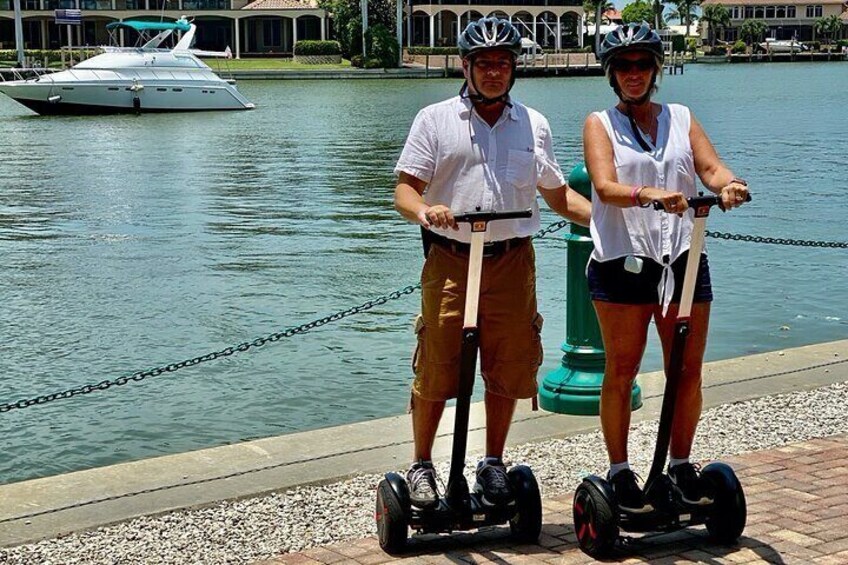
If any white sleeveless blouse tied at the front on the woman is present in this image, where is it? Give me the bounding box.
[589,104,697,306]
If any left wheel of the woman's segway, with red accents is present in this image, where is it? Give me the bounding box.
[573,478,618,559]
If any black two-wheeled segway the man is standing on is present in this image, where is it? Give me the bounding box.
[375,210,542,554]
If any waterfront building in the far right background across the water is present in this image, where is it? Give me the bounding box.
[701,0,848,43]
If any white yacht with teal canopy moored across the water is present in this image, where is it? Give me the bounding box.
[0,18,254,115]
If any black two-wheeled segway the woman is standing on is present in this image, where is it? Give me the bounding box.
[573,194,751,558]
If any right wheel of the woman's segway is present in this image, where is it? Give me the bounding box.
[701,463,748,545]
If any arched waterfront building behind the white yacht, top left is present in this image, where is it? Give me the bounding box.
[0,0,329,57]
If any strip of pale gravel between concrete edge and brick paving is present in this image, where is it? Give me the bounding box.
[0,383,848,565]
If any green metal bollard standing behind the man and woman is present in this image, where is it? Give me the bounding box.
[539,163,642,416]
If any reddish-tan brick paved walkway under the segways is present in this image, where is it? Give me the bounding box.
[262,435,848,565]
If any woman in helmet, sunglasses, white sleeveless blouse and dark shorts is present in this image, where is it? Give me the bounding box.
[575,23,748,549]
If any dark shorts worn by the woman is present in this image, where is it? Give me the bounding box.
[587,251,713,304]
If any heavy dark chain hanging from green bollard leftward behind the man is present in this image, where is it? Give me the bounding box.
[0,220,569,413]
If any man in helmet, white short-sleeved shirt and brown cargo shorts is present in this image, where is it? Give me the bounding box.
[378,18,589,549]
